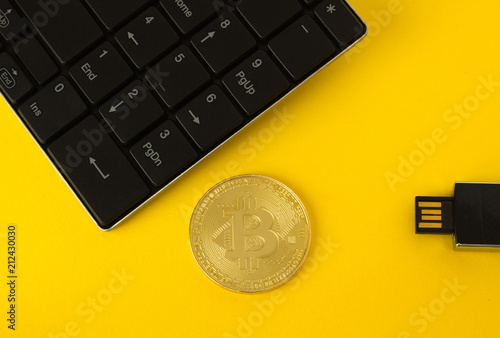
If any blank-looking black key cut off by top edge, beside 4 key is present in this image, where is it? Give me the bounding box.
[86,0,150,30]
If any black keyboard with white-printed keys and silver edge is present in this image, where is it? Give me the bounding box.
[0,0,366,230]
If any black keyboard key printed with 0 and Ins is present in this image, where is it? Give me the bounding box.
[19,76,87,143]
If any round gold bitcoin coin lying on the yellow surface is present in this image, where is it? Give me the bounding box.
[189,175,311,293]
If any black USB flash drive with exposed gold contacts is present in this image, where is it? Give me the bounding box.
[415,183,500,248]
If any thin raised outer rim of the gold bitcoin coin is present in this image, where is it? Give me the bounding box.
[189,174,311,295]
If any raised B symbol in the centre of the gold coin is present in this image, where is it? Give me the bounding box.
[223,197,279,271]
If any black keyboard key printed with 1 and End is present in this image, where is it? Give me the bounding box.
[69,42,133,103]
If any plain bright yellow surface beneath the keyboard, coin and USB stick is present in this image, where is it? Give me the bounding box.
[0,0,500,338]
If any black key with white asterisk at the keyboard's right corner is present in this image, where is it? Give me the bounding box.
[314,0,364,46]
